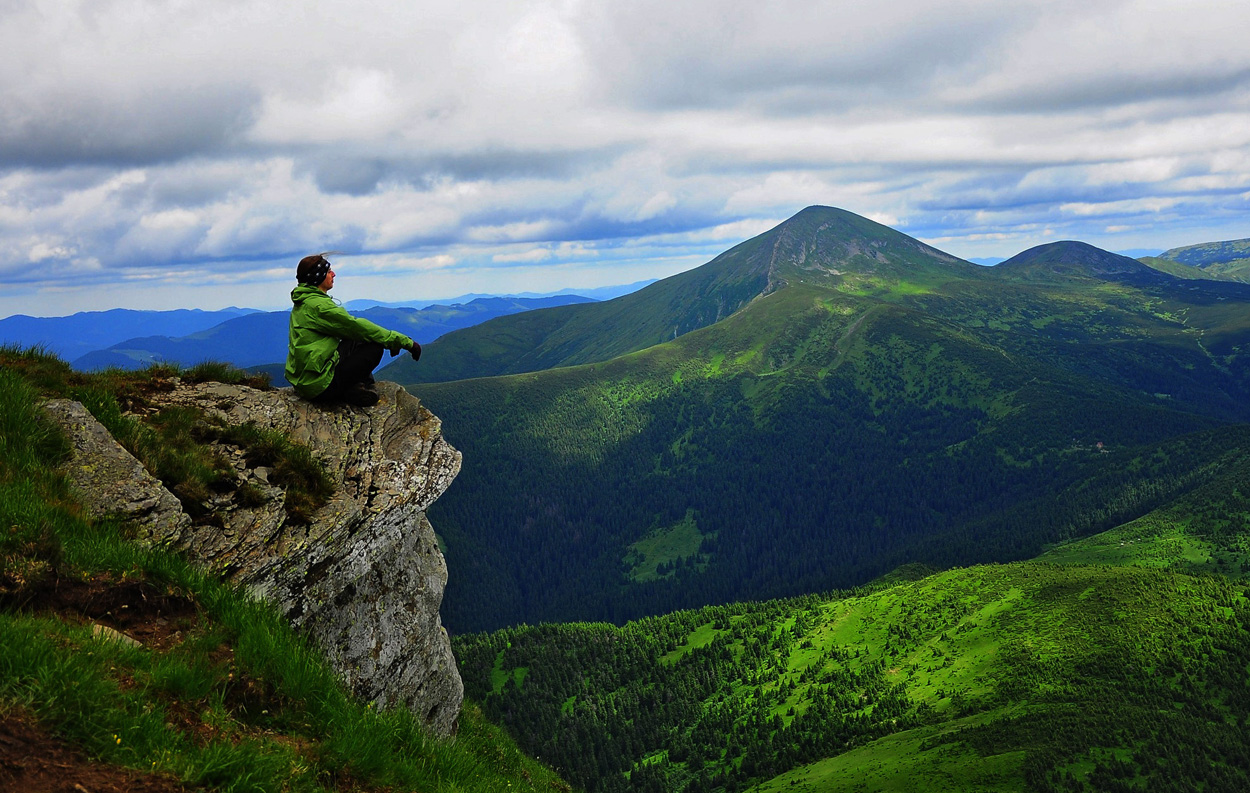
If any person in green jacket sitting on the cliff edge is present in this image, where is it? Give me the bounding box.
[286,254,421,408]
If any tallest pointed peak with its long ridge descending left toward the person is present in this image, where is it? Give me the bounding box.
[384,206,983,383]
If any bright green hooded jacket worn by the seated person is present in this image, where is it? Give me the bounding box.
[286,285,413,399]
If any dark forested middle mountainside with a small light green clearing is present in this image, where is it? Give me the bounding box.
[410,262,1250,630]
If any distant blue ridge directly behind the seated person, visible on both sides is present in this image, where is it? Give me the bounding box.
[73,295,593,370]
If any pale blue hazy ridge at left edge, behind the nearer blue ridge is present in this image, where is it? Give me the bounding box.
[0,306,258,360]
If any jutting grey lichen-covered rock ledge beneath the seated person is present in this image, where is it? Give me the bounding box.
[49,383,464,735]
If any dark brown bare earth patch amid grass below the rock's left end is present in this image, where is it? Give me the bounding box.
[0,574,199,650]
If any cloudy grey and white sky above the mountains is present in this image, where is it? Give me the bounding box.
[0,0,1250,315]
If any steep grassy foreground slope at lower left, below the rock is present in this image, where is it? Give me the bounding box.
[0,351,566,792]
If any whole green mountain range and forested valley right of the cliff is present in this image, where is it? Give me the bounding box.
[409,208,1250,793]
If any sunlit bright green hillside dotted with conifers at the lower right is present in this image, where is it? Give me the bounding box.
[458,555,1250,790]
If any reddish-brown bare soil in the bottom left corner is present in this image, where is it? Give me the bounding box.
[0,710,186,793]
